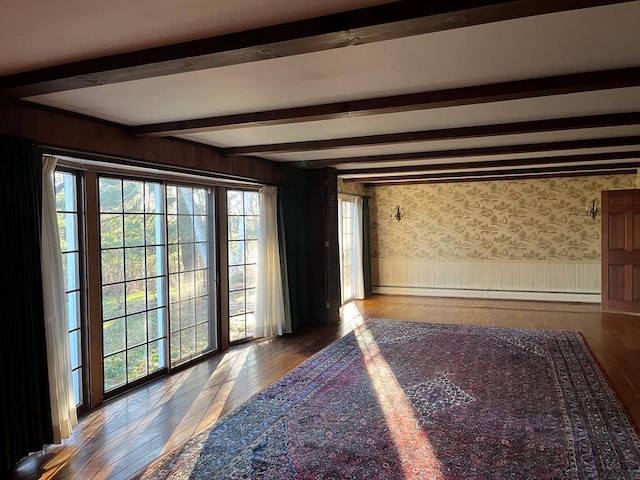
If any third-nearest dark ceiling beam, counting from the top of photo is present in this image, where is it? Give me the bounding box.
[222,112,640,156]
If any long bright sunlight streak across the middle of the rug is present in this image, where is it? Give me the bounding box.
[356,327,445,480]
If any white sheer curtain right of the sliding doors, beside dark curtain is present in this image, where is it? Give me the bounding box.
[255,187,285,337]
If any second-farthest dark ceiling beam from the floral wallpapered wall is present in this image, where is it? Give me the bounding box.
[338,150,640,175]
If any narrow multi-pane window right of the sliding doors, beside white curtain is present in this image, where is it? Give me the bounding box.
[227,190,260,342]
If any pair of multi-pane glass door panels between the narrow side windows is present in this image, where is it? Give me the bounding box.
[98,176,216,393]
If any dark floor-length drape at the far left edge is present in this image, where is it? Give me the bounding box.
[0,135,53,470]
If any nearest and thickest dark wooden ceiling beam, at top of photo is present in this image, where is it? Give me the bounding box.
[0,0,630,98]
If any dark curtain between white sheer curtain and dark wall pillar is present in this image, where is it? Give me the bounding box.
[278,186,309,332]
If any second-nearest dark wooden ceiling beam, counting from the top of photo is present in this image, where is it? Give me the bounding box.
[129,67,640,136]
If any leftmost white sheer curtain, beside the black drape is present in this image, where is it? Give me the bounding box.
[41,156,78,443]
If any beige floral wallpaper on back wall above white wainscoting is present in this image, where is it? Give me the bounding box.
[370,175,636,261]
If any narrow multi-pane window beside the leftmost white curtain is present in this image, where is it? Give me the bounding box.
[55,171,83,406]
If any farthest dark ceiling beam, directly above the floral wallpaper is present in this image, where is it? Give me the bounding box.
[343,161,640,184]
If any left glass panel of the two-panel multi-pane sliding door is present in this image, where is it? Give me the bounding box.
[99,177,167,392]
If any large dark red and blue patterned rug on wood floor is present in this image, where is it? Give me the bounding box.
[136,320,640,480]
